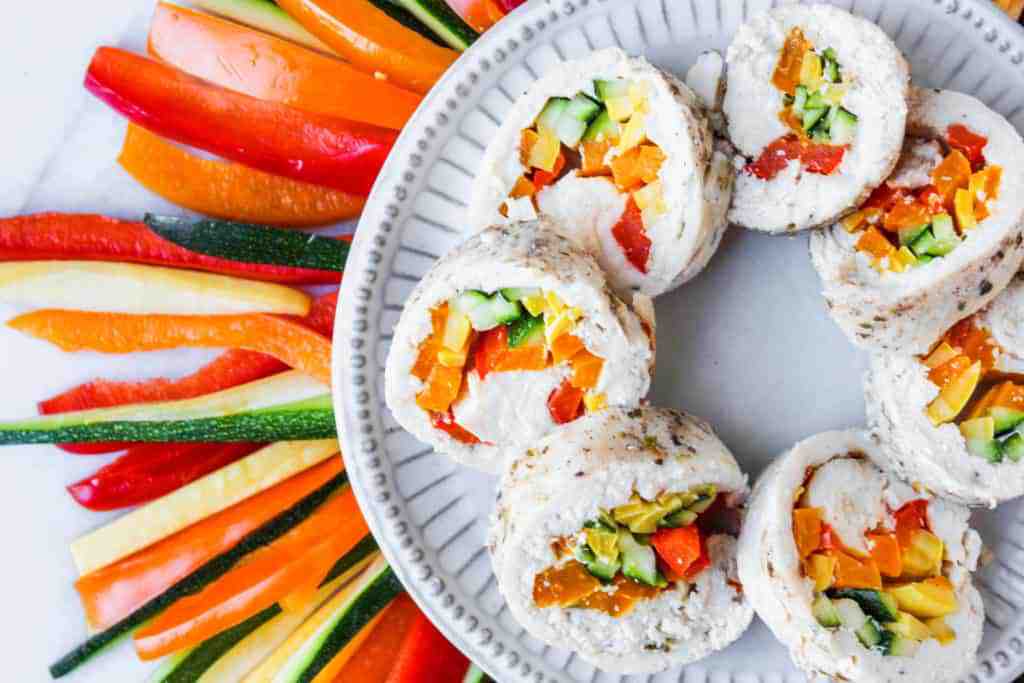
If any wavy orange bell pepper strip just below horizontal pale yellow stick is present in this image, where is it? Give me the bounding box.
[7,309,331,386]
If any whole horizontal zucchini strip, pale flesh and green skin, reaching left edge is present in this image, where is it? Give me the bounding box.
[0,371,336,445]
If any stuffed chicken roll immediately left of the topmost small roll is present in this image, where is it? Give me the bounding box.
[469,48,733,296]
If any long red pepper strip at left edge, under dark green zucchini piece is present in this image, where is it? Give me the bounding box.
[0,213,341,285]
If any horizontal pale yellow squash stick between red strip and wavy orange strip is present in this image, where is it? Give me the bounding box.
[0,261,309,315]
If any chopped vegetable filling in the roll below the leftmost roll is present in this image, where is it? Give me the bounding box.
[534,484,718,617]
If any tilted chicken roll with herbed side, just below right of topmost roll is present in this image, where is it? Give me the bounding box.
[811,88,1024,353]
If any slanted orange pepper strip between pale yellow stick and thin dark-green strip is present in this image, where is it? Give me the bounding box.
[75,458,343,630]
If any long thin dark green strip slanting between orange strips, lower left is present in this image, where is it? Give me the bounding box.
[50,472,348,678]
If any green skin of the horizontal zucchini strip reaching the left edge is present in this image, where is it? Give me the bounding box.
[0,409,338,445]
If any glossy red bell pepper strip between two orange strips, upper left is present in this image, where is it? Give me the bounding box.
[85,47,397,196]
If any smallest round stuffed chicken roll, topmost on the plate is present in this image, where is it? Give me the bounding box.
[724,4,910,232]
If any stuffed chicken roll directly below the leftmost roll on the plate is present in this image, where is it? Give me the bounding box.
[489,408,753,673]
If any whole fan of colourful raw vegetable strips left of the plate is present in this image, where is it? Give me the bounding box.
[0,0,518,683]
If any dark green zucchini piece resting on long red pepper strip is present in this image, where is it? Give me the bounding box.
[145,214,349,272]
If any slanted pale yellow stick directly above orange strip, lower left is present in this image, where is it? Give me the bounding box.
[71,438,338,574]
